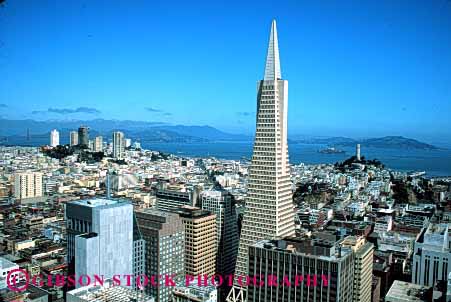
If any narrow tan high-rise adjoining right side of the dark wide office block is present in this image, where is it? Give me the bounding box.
[341,236,374,302]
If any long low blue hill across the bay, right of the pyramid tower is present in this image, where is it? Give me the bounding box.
[295,136,440,150]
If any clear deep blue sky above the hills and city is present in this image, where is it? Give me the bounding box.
[0,0,451,141]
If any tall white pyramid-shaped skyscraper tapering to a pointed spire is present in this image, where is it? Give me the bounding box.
[228,20,295,301]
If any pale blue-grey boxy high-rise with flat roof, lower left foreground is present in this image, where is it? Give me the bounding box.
[66,199,133,286]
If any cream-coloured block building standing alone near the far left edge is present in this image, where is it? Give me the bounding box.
[14,172,42,199]
